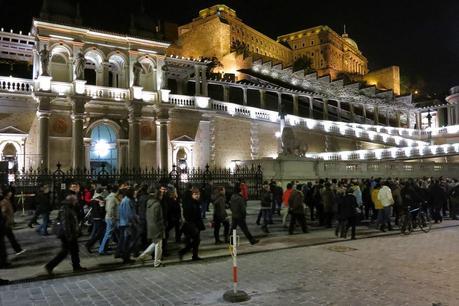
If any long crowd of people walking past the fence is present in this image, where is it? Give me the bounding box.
[0,178,459,282]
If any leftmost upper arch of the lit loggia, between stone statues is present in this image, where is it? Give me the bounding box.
[49,43,72,82]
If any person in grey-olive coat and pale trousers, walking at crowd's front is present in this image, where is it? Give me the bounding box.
[138,187,166,268]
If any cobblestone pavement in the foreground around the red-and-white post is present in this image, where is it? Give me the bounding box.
[0,221,459,306]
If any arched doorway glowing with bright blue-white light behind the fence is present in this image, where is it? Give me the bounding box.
[89,123,118,172]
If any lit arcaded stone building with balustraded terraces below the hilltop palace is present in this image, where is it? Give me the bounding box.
[0,11,459,177]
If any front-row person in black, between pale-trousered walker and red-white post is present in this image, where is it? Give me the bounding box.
[179,187,205,261]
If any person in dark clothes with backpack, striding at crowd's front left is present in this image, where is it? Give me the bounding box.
[45,195,87,275]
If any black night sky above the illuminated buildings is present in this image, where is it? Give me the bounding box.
[0,0,459,94]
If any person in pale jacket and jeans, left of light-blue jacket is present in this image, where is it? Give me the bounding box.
[99,185,120,255]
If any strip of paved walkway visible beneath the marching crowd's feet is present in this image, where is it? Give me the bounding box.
[0,202,459,282]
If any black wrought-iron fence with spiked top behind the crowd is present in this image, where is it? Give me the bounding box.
[10,164,263,206]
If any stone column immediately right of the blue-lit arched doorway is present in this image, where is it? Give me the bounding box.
[128,101,141,170]
